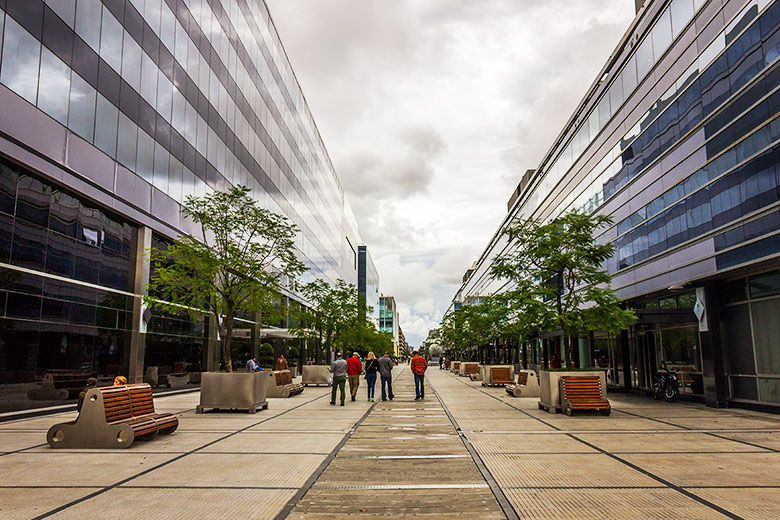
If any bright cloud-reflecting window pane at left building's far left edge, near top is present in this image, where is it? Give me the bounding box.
[0,17,41,104]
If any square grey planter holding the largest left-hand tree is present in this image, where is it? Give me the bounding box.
[195,371,273,413]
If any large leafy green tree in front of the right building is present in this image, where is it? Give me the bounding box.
[491,211,636,367]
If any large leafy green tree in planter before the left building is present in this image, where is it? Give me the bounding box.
[145,186,306,372]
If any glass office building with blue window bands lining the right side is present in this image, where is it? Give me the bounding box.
[456,0,780,412]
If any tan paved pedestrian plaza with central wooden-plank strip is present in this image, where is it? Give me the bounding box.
[0,366,780,520]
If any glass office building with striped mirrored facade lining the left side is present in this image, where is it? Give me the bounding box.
[0,0,360,411]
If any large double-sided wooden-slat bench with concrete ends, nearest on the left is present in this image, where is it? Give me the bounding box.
[46,383,179,448]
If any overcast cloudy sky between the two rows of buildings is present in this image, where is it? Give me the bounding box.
[266,0,634,346]
